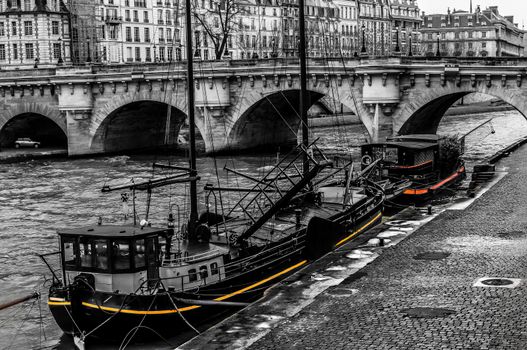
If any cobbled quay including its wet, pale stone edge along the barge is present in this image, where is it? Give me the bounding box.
[180,146,527,349]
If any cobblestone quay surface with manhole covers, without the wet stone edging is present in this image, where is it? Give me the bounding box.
[244,146,527,349]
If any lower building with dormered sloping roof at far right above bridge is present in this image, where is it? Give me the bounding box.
[420,6,524,57]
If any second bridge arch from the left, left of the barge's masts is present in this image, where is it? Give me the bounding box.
[90,98,190,153]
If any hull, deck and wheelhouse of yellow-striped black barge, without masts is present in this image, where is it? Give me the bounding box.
[43,148,383,341]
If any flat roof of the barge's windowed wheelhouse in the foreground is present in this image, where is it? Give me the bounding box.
[57,225,168,238]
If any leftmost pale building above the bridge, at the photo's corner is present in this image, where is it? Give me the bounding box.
[0,0,71,69]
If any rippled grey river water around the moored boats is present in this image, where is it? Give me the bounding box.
[0,111,527,349]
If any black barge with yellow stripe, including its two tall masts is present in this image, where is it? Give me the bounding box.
[41,0,384,348]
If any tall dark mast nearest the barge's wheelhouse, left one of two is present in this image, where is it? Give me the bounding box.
[185,0,198,234]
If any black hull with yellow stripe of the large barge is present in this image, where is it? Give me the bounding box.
[48,200,383,342]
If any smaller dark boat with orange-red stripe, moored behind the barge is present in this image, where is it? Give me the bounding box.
[361,134,466,204]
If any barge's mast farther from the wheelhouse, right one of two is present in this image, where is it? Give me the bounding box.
[298,0,309,176]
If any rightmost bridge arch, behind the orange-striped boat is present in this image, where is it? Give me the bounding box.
[393,82,527,135]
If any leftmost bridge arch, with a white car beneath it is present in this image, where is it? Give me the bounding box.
[0,103,68,148]
